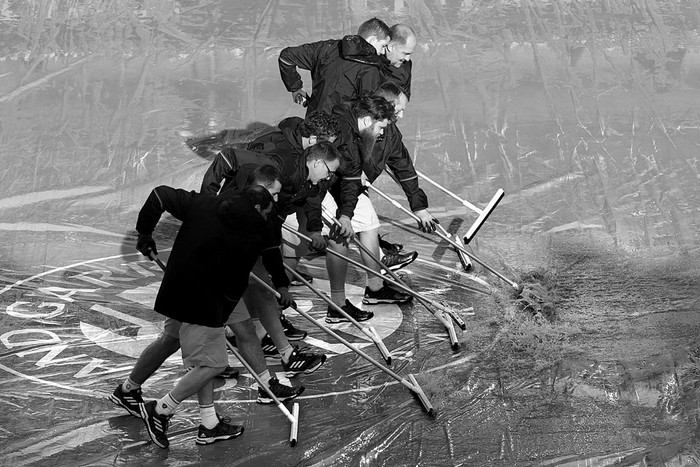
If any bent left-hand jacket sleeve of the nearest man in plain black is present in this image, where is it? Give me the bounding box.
[136,185,197,235]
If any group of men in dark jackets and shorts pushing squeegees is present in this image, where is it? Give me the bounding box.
[110,18,437,448]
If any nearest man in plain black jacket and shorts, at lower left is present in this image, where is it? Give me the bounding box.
[126,186,292,448]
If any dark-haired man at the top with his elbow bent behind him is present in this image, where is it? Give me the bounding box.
[278,18,390,114]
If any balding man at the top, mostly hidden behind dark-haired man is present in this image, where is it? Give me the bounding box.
[381,24,418,99]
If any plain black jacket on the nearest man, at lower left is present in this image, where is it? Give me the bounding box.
[136,186,289,327]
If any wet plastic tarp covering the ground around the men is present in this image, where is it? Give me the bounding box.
[0,0,700,466]
